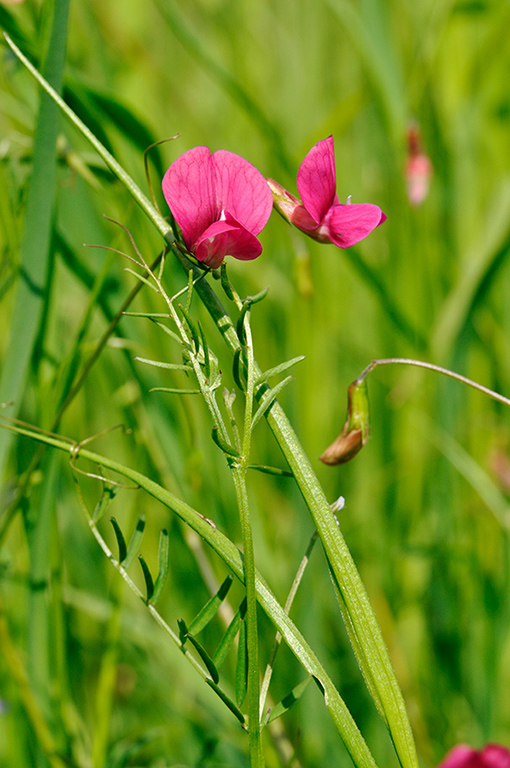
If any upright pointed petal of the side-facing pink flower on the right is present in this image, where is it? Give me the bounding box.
[297,136,337,224]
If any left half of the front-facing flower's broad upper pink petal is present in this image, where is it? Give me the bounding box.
[162,147,214,249]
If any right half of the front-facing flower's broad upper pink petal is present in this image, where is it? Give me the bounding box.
[212,149,273,235]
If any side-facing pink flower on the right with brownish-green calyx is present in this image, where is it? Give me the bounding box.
[267,136,386,248]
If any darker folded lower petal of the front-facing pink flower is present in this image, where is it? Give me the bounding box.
[195,217,262,269]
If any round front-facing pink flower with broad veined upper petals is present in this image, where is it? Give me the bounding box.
[162,147,273,269]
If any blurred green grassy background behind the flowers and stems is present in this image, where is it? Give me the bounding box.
[0,0,510,768]
